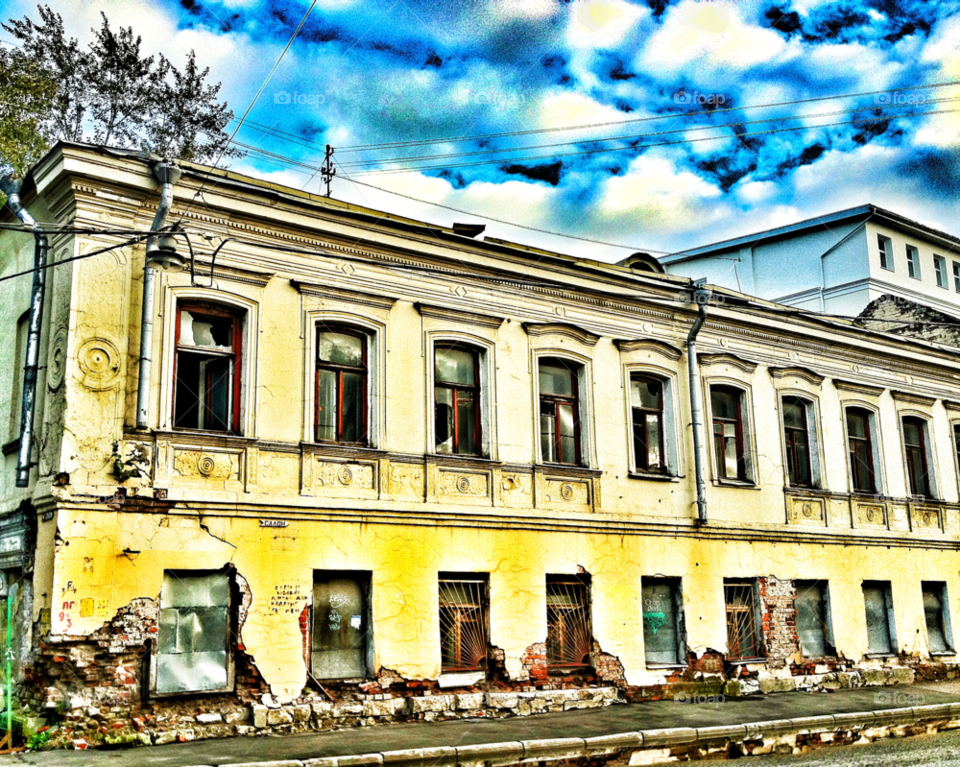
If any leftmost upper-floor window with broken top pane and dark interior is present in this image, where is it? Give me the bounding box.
[173,305,242,434]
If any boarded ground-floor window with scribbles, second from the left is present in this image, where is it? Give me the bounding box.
[310,570,371,679]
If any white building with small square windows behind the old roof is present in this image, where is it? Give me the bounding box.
[660,205,960,316]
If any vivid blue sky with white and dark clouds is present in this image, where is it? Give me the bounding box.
[0,0,960,261]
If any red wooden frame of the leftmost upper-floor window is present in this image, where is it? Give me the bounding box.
[170,299,246,436]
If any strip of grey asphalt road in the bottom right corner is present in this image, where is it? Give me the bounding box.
[684,730,960,767]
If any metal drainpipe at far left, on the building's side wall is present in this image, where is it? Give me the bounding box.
[0,178,48,487]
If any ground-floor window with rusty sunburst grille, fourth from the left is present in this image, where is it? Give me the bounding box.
[547,575,593,668]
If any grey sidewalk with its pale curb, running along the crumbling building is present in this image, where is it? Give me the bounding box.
[0,684,960,767]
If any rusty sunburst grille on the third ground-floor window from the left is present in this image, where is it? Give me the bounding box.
[440,579,488,671]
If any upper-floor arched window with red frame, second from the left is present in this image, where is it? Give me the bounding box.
[314,326,368,444]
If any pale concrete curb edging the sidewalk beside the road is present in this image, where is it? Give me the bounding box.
[184,703,960,767]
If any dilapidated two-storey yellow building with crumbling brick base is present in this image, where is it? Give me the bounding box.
[0,144,960,743]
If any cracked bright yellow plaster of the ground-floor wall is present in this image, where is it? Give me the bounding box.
[45,511,960,700]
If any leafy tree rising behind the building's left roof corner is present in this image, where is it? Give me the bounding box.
[0,5,243,184]
